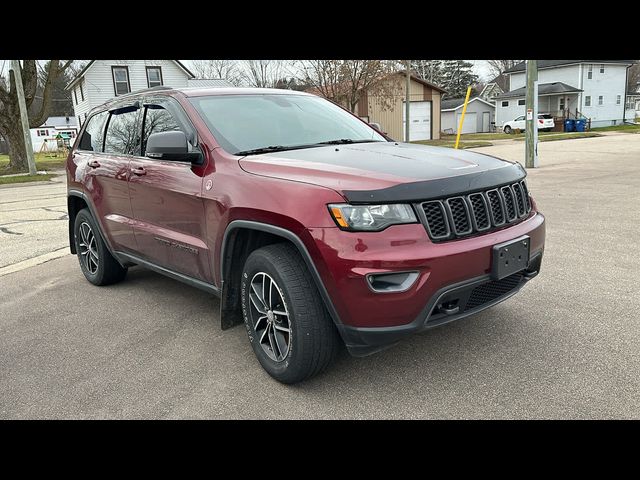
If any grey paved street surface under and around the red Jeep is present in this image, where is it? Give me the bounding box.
[0,134,640,419]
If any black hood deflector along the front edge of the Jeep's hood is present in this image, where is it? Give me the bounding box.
[342,163,527,204]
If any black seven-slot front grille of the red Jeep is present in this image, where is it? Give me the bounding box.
[420,180,531,242]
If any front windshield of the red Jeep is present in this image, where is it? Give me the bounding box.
[189,94,386,154]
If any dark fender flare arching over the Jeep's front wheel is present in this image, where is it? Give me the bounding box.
[220,220,343,335]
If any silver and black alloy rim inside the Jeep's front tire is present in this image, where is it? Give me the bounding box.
[249,272,291,362]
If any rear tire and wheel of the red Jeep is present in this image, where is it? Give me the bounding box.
[73,208,127,286]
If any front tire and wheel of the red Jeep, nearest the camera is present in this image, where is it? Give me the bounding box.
[240,243,340,384]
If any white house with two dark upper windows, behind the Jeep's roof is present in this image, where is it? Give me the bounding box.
[65,60,194,126]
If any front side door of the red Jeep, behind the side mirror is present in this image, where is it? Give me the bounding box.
[129,97,213,283]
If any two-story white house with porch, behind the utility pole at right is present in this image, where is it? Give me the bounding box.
[495,60,633,127]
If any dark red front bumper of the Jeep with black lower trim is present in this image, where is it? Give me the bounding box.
[310,213,545,356]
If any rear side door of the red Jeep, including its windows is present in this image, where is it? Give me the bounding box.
[75,106,140,251]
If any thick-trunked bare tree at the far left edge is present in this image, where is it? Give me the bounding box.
[0,60,73,172]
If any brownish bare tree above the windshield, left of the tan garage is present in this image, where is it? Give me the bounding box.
[301,60,398,112]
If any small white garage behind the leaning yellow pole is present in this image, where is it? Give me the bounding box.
[440,96,496,134]
